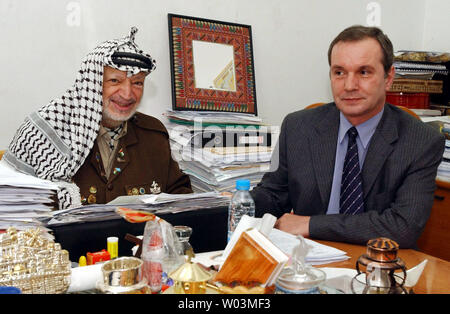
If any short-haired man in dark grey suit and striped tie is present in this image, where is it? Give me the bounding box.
[252,26,445,248]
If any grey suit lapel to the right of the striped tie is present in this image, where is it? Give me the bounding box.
[362,105,398,198]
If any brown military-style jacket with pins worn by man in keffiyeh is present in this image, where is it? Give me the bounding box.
[73,112,192,204]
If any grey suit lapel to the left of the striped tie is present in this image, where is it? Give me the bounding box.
[309,106,339,212]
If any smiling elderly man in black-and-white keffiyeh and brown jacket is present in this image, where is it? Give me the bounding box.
[3,27,192,209]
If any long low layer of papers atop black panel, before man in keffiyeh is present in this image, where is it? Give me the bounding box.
[48,192,230,226]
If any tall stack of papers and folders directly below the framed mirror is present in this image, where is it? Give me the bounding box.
[166,111,278,192]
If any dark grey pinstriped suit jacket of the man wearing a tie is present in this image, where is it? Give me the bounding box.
[252,103,445,248]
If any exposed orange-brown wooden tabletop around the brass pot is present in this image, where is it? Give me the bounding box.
[316,240,450,294]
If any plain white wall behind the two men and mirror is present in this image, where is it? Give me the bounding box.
[0,0,444,149]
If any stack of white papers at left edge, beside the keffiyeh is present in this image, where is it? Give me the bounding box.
[0,161,58,230]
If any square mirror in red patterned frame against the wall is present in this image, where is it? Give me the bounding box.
[168,14,257,115]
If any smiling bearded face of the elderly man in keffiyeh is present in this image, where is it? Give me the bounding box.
[102,67,146,128]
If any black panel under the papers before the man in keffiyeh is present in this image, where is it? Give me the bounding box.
[50,207,228,262]
